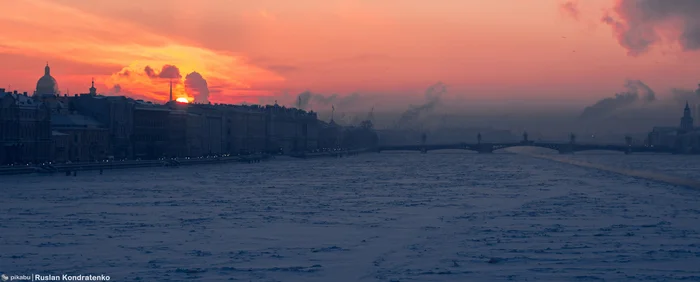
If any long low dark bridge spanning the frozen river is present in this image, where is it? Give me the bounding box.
[377,132,674,154]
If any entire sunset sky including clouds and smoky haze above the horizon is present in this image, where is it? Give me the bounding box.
[0,0,700,139]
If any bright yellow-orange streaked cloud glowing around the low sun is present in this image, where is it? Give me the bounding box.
[0,0,285,102]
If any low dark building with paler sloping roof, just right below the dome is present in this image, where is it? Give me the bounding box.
[51,114,109,162]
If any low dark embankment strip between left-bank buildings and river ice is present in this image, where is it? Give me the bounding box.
[0,149,378,176]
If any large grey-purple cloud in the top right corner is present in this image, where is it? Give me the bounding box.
[602,0,700,56]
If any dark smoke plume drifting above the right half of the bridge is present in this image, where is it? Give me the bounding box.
[581,80,656,119]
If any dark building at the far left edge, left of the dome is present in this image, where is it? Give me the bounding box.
[0,88,51,164]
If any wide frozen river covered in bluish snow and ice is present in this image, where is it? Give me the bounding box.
[0,152,700,281]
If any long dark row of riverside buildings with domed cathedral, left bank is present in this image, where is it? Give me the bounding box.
[0,64,378,164]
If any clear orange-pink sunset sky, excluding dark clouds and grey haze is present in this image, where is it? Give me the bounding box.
[0,0,700,108]
